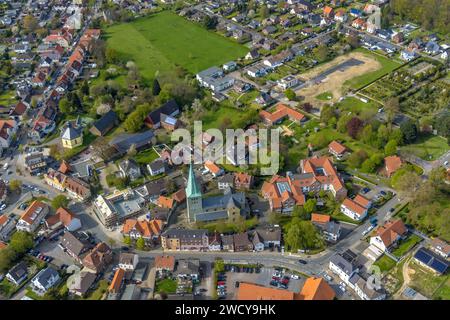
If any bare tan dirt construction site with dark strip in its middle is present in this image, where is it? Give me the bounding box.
[296,52,382,106]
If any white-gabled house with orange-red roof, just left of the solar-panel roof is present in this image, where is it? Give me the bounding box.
[370,219,408,251]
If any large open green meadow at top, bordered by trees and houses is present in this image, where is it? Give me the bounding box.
[105,11,248,78]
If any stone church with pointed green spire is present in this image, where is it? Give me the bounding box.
[186,164,249,222]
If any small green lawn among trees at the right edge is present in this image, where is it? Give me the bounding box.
[401,135,450,160]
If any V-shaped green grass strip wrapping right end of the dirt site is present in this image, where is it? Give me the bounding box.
[345,48,401,90]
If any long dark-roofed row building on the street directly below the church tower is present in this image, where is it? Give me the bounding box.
[161,229,208,251]
